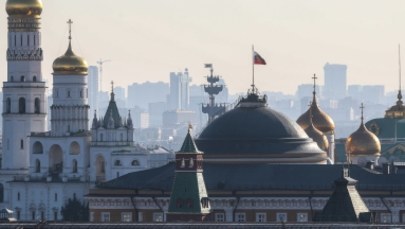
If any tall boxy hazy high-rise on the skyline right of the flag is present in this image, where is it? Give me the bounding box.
[323,63,347,99]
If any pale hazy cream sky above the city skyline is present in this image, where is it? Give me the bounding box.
[0,0,405,93]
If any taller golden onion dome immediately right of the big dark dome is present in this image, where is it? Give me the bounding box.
[297,94,335,133]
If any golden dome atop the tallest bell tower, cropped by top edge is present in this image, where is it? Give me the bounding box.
[6,0,43,16]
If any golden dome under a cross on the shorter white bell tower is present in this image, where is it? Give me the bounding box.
[52,42,88,75]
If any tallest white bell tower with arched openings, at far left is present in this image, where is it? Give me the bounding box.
[2,0,47,170]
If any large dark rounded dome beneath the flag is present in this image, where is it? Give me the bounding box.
[196,90,327,164]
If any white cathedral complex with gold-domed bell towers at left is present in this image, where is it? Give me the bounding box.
[0,0,174,220]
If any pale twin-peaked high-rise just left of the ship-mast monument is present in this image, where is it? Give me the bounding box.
[168,68,191,110]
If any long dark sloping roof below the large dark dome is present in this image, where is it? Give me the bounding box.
[99,162,405,193]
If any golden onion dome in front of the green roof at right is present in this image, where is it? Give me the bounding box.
[346,121,381,155]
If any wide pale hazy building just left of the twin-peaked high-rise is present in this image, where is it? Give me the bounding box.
[127,82,169,109]
